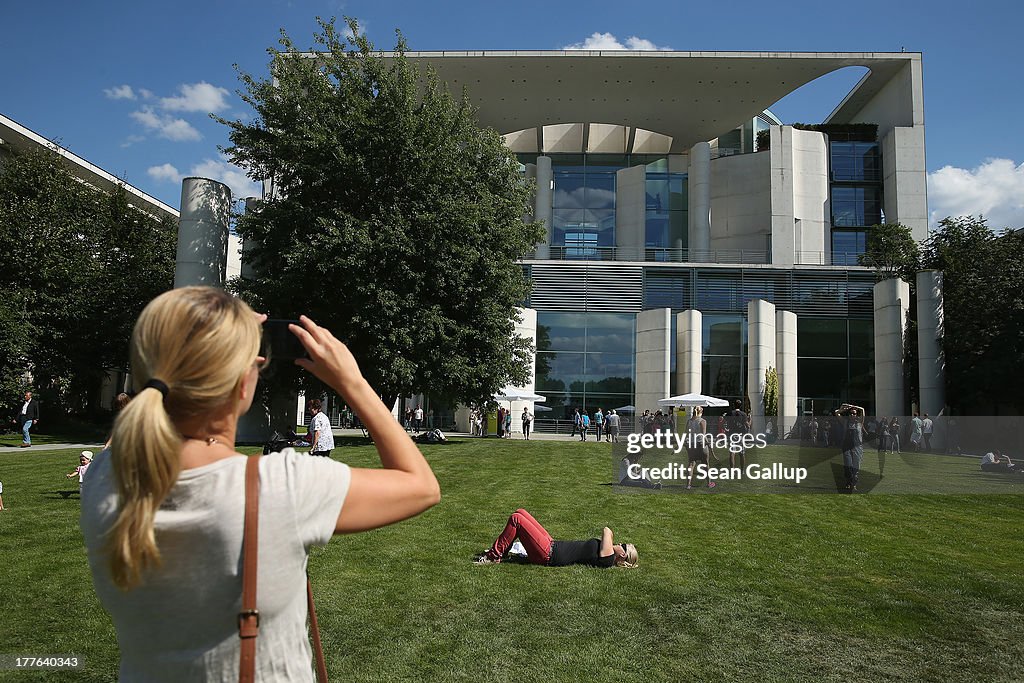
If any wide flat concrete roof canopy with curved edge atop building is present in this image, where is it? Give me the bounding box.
[393,50,921,154]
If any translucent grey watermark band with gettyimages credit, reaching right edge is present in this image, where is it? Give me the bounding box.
[611,413,1024,495]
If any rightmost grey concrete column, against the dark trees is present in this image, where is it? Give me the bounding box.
[918,270,946,419]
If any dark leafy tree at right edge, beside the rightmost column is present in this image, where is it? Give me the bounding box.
[923,216,1024,415]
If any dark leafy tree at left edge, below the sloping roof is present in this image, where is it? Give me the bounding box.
[0,150,177,420]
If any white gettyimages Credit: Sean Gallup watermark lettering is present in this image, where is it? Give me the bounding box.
[620,429,807,488]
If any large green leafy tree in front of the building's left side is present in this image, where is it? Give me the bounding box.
[221,19,543,404]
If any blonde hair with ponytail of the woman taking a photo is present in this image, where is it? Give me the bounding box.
[106,287,260,590]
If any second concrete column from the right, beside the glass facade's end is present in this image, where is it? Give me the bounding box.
[873,279,910,417]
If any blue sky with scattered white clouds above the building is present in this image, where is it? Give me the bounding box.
[8,0,1024,227]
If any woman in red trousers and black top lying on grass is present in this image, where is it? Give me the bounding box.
[475,508,639,569]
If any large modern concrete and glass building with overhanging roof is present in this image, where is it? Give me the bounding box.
[407,50,941,428]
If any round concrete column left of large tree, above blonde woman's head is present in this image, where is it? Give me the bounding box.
[174,178,231,288]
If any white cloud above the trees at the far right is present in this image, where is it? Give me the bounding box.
[928,159,1024,229]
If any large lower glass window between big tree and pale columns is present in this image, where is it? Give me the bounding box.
[536,312,636,419]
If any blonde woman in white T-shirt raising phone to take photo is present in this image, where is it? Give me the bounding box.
[81,287,440,681]
